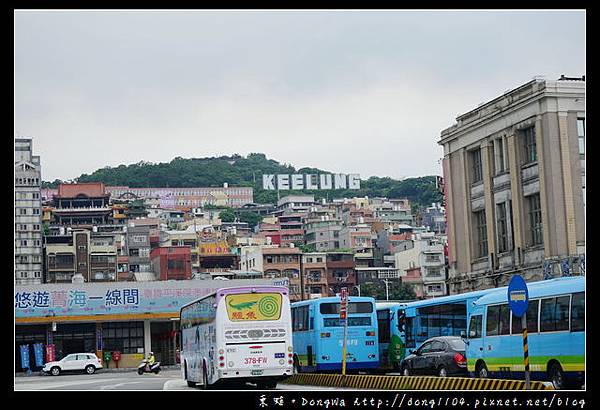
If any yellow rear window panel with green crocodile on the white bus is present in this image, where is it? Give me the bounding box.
[225,293,282,322]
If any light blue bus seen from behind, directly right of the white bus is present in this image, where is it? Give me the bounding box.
[292,296,379,372]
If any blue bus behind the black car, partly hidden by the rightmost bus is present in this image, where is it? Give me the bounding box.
[399,288,496,353]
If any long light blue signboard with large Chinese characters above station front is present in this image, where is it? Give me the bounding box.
[14,278,289,320]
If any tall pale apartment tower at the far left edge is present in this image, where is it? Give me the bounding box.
[15,138,43,285]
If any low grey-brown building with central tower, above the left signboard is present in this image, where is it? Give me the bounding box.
[45,228,118,283]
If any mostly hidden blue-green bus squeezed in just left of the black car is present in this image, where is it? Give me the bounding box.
[375,302,406,371]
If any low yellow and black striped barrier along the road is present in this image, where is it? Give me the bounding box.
[282,373,553,390]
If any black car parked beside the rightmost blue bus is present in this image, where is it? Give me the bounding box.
[400,336,469,377]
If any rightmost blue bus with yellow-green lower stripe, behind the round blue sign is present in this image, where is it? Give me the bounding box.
[466,276,585,389]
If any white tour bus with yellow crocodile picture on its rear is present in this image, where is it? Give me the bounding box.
[180,285,293,389]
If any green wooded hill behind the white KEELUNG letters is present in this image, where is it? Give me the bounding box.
[43,153,442,210]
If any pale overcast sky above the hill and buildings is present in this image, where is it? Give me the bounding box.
[14,10,585,180]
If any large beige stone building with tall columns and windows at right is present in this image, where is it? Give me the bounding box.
[439,77,585,293]
